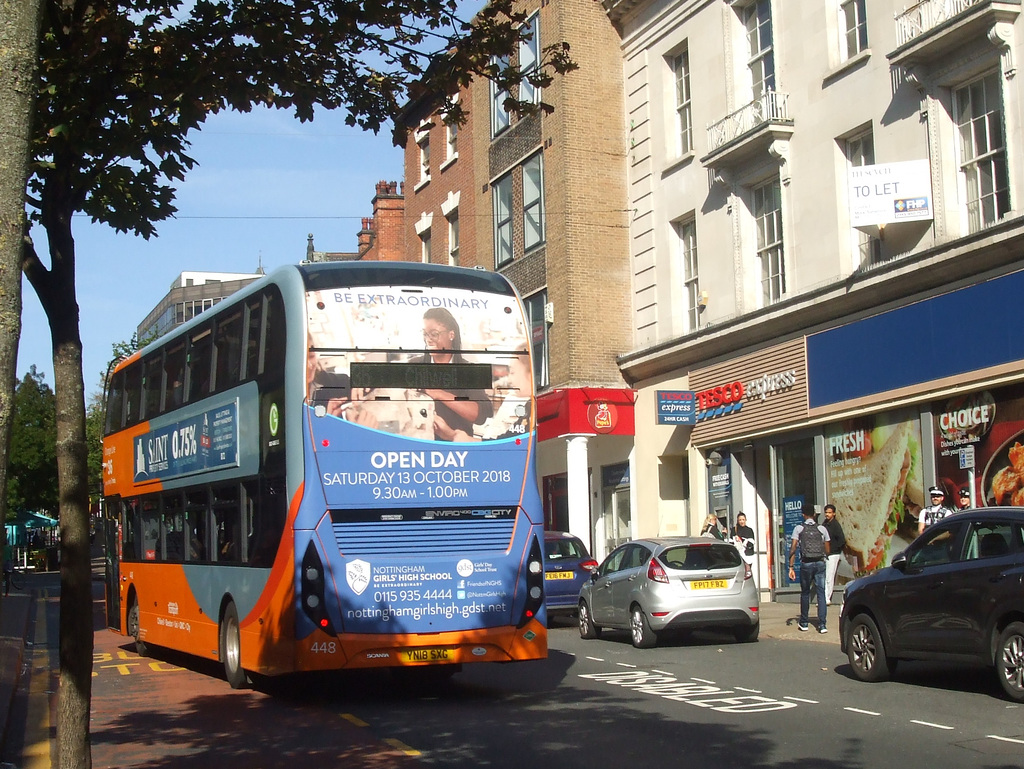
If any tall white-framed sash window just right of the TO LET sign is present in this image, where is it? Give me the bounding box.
[953,72,1010,232]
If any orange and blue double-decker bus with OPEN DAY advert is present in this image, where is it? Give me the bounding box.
[103,262,547,688]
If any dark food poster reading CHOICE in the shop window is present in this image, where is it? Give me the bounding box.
[933,386,1024,506]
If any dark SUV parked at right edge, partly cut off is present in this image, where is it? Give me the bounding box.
[840,508,1024,702]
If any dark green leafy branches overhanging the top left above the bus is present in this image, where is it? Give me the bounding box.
[30,0,574,238]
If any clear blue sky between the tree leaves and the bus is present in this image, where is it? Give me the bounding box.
[17,103,402,396]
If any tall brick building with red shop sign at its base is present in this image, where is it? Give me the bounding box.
[404,0,636,555]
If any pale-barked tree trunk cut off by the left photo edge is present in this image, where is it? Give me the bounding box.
[0,0,43,589]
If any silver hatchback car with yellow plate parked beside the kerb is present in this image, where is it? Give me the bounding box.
[579,537,761,648]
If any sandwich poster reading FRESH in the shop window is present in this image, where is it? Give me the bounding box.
[825,413,925,583]
